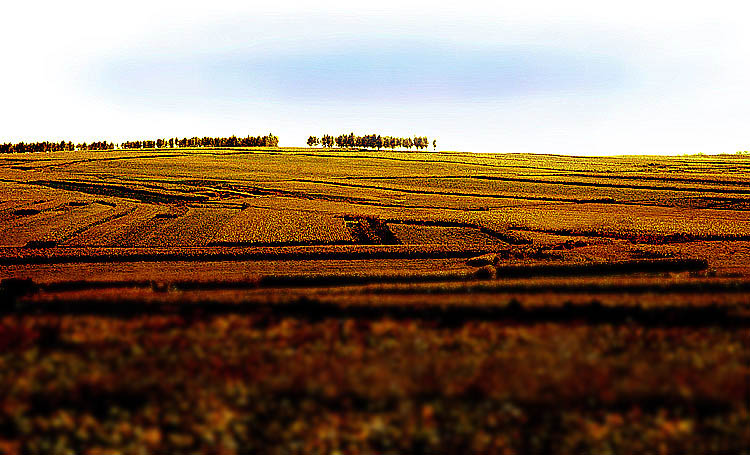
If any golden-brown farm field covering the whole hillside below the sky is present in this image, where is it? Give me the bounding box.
[0,148,750,454]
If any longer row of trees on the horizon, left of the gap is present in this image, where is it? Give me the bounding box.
[0,133,279,153]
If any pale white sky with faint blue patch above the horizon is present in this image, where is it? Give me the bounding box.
[0,0,750,155]
